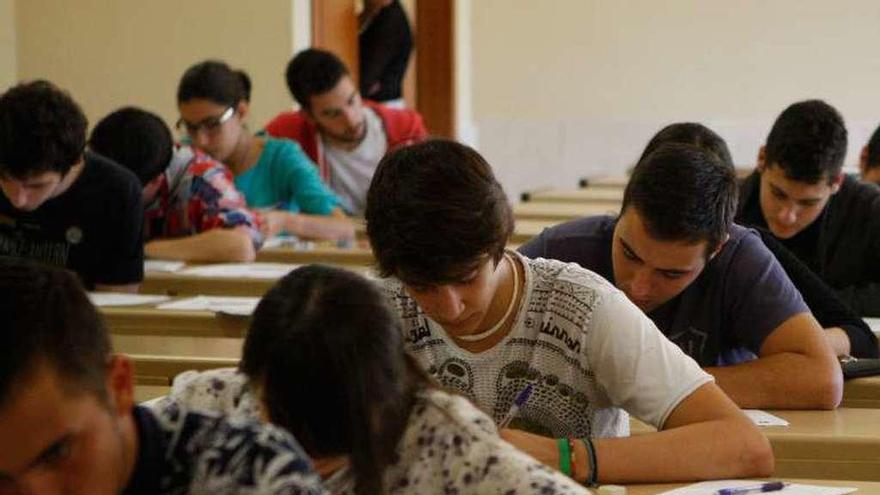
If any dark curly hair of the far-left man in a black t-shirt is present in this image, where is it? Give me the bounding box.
[0,80,88,179]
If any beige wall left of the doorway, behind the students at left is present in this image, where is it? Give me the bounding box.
[16,0,293,132]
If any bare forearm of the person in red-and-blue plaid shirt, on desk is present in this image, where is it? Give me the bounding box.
[144,228,256,262]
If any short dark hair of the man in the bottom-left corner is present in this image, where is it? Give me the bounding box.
[0,257,111,405]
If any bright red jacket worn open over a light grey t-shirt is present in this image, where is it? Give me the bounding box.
[266,100,428,181]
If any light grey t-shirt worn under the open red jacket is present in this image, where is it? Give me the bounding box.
[324,107,388,216]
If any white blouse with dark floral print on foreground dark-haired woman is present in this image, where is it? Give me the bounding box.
[157,369,589,495]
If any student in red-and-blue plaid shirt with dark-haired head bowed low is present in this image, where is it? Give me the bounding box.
[89,107,263,262]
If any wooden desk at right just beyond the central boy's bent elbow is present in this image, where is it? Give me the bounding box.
[631,407,880,481]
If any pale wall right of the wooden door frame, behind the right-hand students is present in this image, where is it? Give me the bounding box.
[460,0,880,197]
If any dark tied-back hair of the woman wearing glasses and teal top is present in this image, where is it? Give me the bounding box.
[177,60,251,107]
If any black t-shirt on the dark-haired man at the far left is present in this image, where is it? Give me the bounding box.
[0,152,144,289]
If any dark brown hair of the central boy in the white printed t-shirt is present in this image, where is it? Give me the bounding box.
[364,139,513,286]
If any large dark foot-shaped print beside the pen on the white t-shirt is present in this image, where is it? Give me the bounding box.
[492,361,593,437]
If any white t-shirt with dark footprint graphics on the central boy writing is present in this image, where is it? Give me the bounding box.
[385,252,712,438]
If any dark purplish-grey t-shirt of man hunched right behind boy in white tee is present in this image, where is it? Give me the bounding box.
[519,216,809,366]
